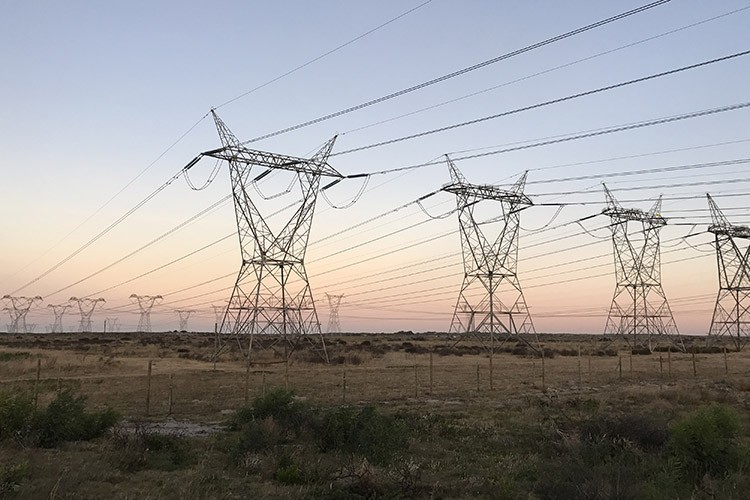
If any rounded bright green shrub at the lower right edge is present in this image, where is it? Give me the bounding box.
[669,405,750,482]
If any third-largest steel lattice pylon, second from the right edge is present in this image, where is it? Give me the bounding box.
[602,184,685,351]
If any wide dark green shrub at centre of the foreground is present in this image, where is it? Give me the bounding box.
[316,406,408,464]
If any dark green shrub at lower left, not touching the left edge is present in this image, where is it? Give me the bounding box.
[33,390,119,448]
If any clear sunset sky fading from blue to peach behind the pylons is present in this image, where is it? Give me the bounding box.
[0,0,750,334]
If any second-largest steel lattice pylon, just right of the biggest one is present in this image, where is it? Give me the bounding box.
[443,155,536,350]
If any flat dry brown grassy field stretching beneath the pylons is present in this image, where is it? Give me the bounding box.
[0,333,750,498]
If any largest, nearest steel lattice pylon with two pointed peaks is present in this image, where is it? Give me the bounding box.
[191,111,343,361]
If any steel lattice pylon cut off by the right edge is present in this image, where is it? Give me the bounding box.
[706,194,750,351]
